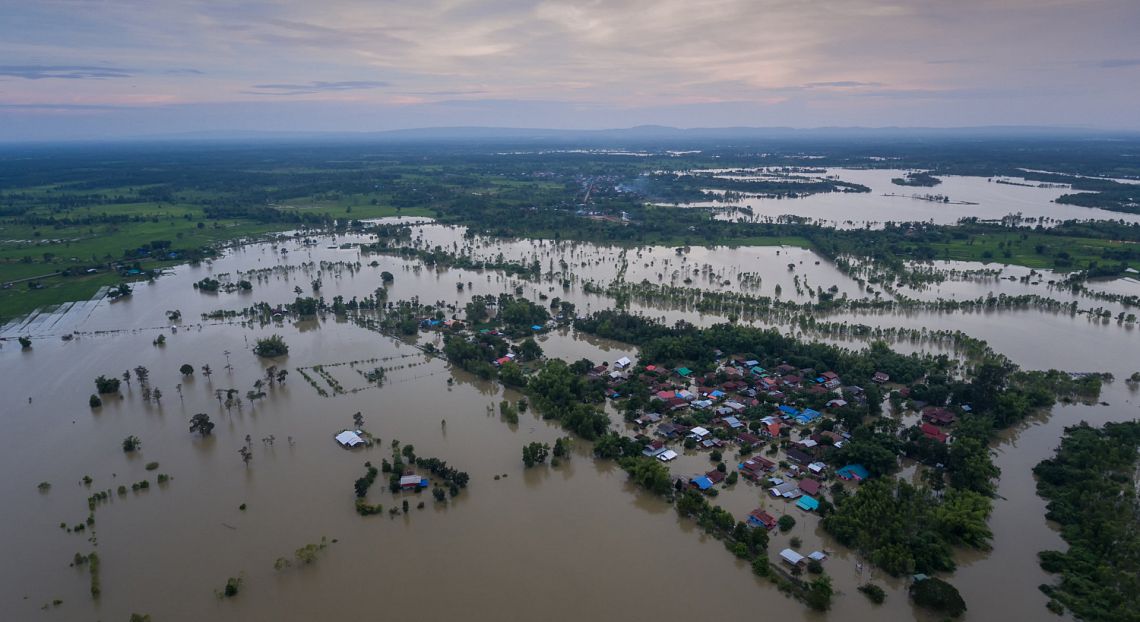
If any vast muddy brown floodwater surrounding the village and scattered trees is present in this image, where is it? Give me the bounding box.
[0,216,1140,621]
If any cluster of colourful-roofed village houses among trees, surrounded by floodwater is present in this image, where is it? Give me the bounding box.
[410,309,970,575]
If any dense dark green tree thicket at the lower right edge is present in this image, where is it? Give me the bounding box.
[1033,422,1140,622]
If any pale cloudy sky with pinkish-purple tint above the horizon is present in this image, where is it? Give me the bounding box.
[0,0,1140,141]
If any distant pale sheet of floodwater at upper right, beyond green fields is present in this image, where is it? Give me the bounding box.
[665,169,1140,228]
